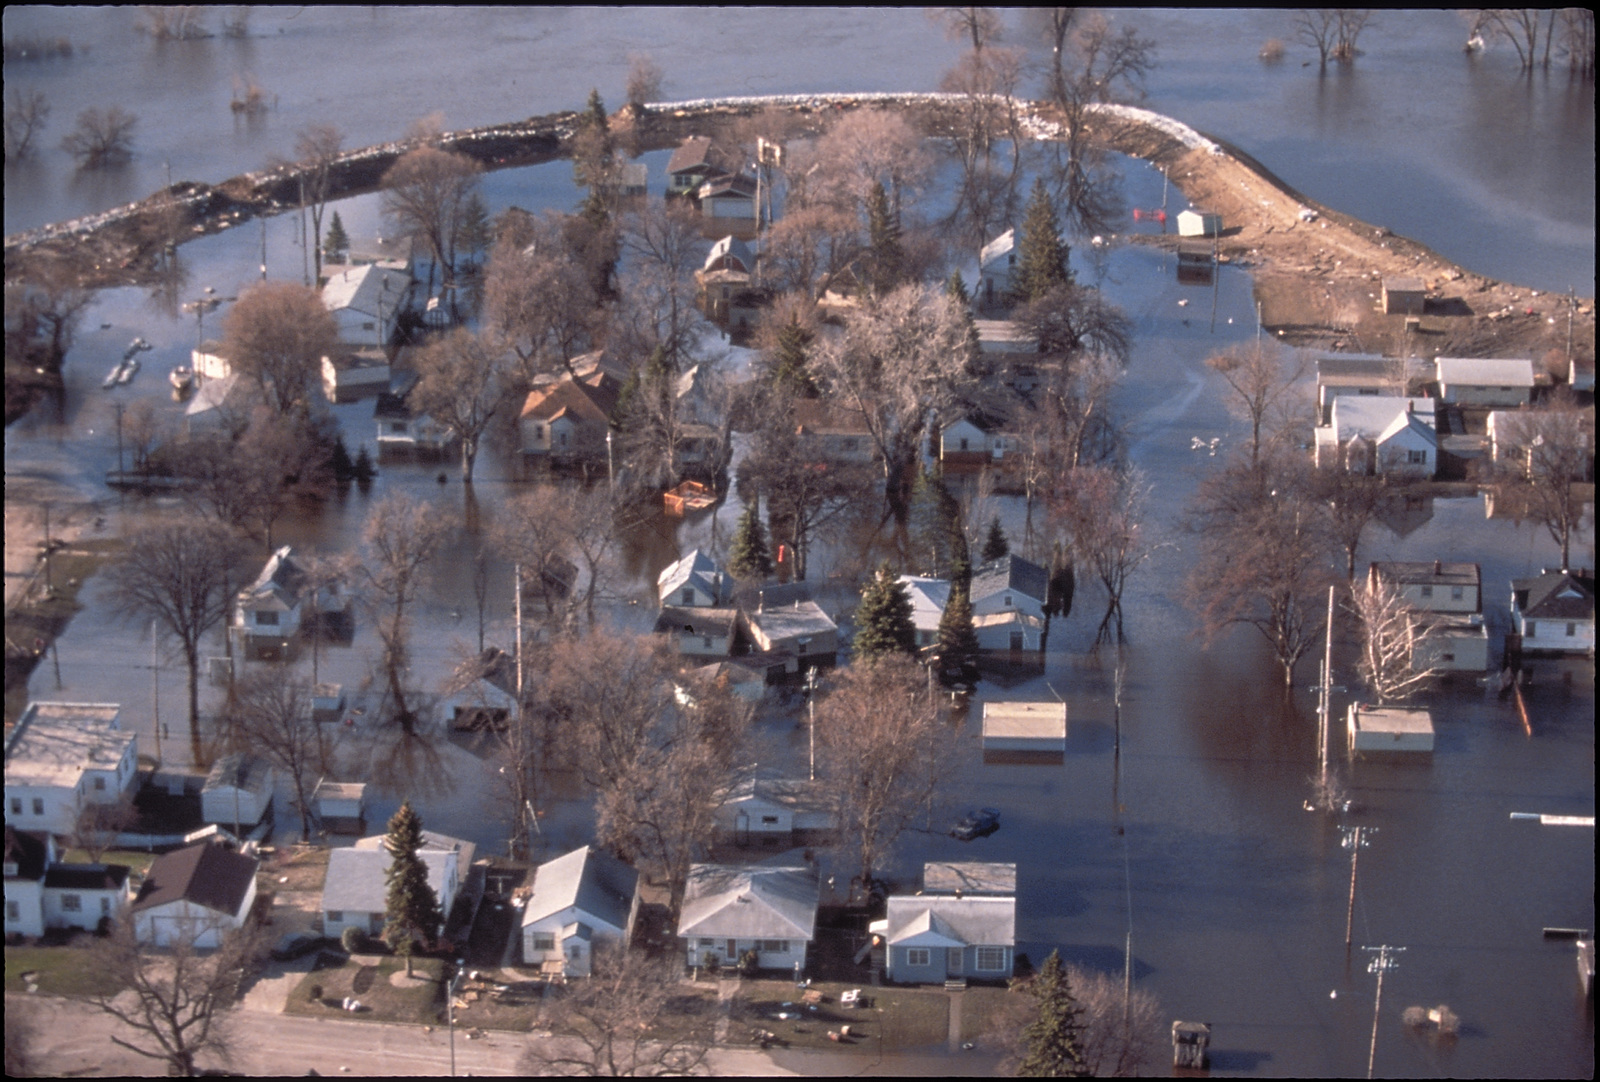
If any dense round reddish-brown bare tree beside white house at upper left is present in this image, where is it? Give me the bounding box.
[222,282,339,415]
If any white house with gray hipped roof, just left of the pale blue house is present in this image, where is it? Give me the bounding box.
[678,864,821,972]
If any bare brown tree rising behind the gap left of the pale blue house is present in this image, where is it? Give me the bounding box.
[816,655,954,888]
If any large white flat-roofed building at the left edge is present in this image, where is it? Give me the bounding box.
[5,703,139,834]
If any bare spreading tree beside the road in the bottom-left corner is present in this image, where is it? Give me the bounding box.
[90,916,262,1077]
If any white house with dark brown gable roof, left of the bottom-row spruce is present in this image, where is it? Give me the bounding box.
[130,842,259,948]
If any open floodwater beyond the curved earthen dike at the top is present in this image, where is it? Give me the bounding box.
[5,5,1595,296]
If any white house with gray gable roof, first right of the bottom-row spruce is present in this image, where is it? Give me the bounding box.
[522,845,638,976]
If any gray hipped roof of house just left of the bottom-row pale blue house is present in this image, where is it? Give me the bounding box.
[678,864,819,940]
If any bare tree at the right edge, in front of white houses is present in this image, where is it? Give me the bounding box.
[1496,407,1595,568]
